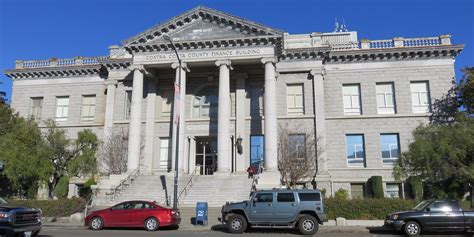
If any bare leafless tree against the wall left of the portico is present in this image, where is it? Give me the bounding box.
[99,128,128,175]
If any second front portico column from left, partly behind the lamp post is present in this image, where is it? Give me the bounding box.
[171,62,188,171]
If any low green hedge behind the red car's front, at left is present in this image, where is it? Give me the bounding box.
[8,198,86,217]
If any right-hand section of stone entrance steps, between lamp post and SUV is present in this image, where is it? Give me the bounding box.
[179,174,252,208]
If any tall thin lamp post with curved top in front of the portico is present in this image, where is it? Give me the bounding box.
[163,35,182,210]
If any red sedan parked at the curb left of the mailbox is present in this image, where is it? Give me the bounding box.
[84,201,181,231]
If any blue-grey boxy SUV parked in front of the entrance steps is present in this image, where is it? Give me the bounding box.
[219,189,327,235]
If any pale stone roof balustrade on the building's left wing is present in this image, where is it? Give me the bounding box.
[15,56,109,69]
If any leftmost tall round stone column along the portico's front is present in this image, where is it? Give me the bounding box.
[127,65,144,172]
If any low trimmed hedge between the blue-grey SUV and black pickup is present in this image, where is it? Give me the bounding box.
[324,198,417,220]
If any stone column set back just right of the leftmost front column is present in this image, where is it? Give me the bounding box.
[144,78,157,173]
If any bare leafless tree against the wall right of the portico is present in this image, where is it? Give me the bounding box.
[278,124,322,189]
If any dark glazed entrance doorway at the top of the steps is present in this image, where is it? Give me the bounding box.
[195,137,217,175]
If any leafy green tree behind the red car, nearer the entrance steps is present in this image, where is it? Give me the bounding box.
[43,120,98,198]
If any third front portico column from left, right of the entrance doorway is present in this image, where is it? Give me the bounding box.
[216,60,231,173]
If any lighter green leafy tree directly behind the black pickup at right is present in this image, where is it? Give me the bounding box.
[394,116,474,206]
